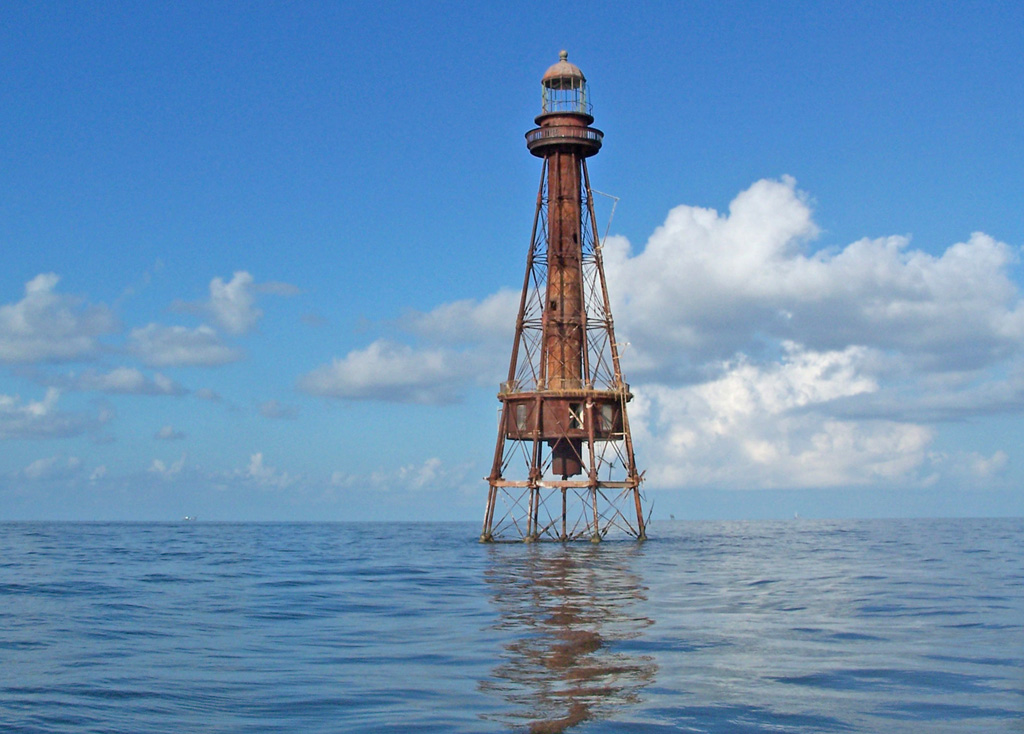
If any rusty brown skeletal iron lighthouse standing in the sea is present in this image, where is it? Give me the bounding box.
[480,51,645,542]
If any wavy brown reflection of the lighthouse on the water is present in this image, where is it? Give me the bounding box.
[480,543,657,733]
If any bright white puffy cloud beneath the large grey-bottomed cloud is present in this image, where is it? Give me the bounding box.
[631,344,933,488]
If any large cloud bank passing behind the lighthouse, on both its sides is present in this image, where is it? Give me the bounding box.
[299,177,1024,487]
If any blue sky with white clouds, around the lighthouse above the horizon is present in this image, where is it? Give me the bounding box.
[0,2,1024,520]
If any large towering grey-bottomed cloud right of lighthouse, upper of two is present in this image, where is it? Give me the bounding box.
[605,178,1024,376]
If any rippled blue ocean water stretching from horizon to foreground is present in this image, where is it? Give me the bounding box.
[0,519,1024,734]
